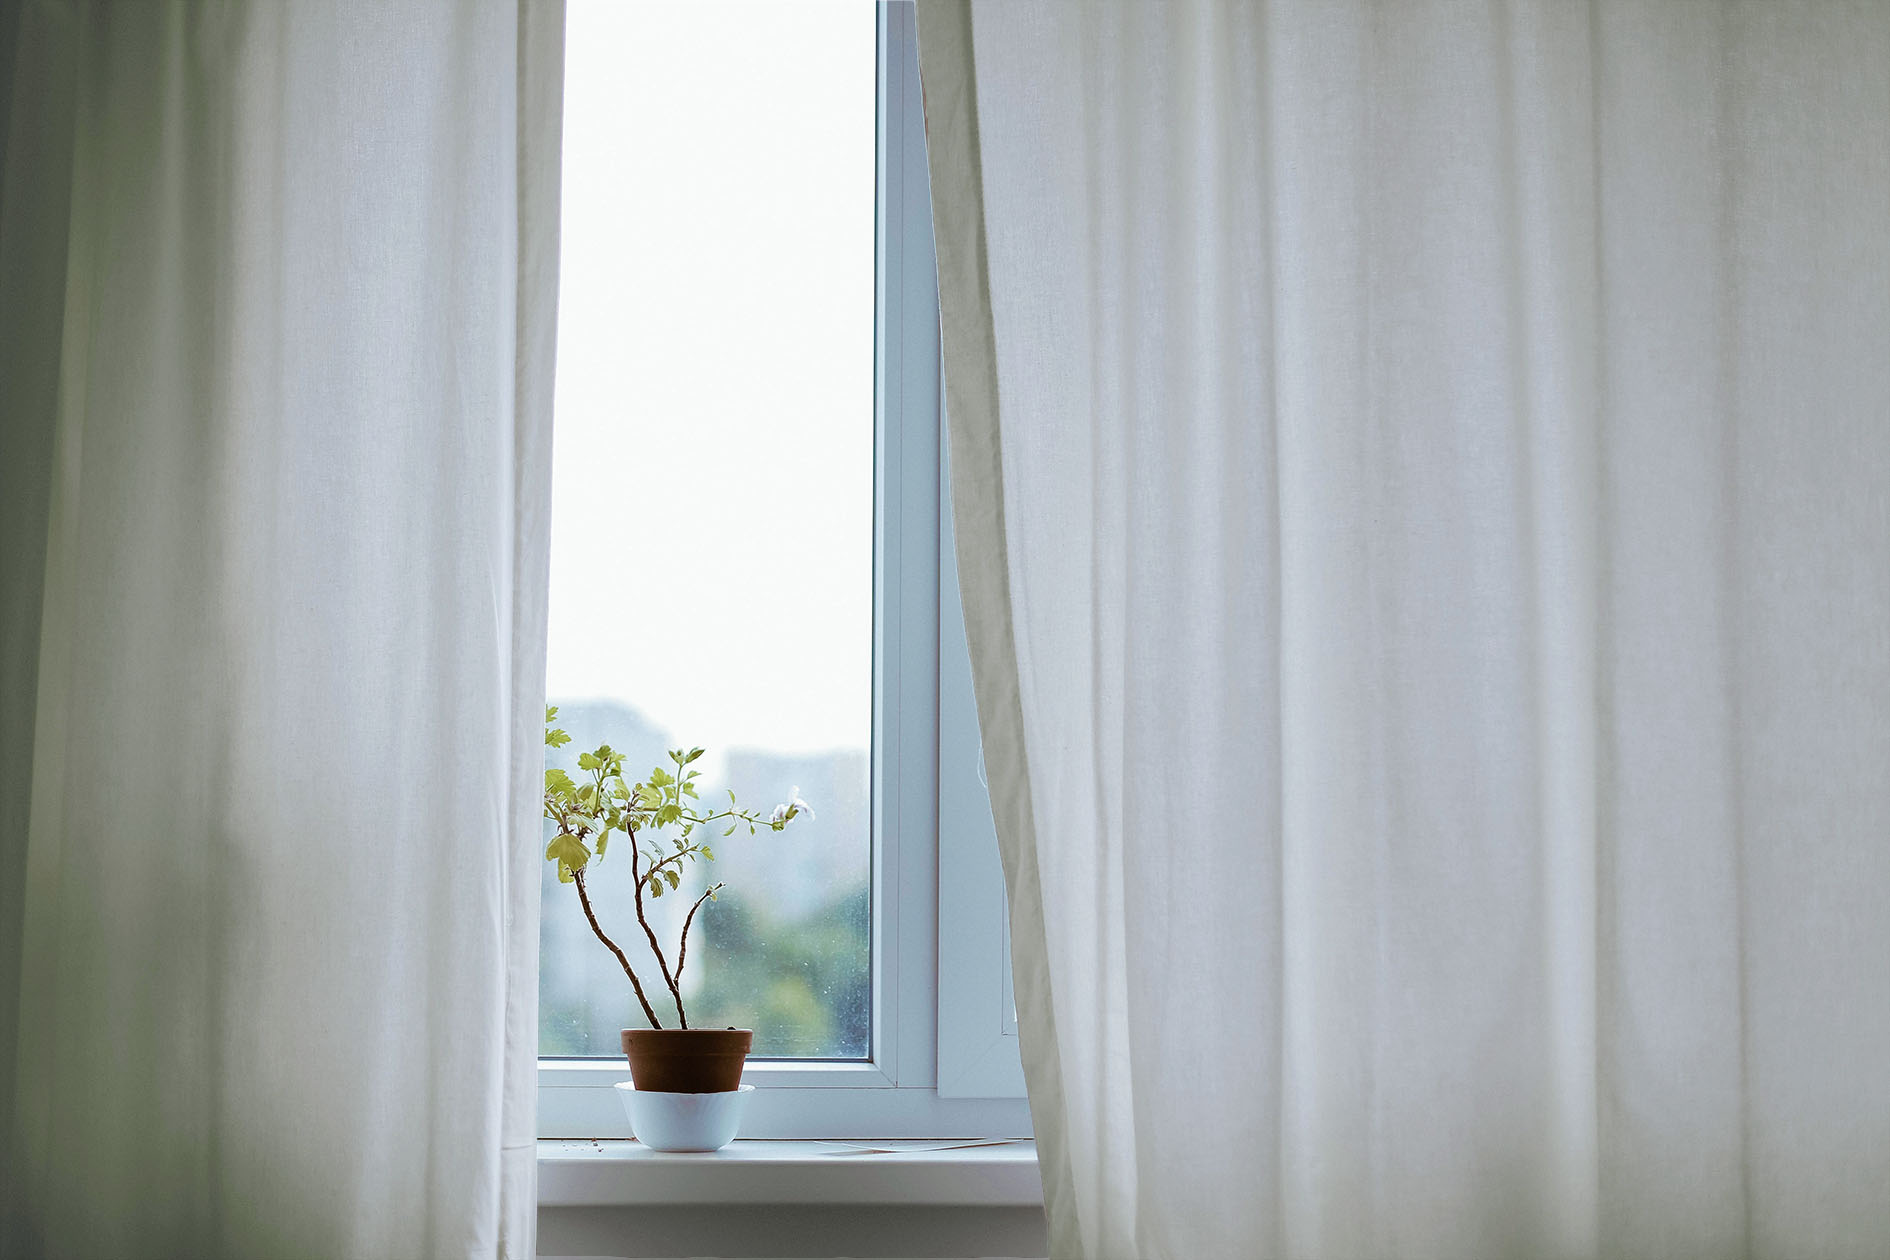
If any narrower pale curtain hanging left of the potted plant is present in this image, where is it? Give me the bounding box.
[0,0,563,1258]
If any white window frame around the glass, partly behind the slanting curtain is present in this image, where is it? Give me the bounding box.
[539,0,1030,1137]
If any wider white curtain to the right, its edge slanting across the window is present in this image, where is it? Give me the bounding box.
[919,0,1890,1260]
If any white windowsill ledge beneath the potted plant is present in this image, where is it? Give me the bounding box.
[539,1139,1043,1207]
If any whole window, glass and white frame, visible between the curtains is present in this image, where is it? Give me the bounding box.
[539,0,1028,1137]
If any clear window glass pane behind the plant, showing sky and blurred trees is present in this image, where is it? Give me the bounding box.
[539,0,875,1058]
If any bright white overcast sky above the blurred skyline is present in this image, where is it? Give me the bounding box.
[546,0,875,752]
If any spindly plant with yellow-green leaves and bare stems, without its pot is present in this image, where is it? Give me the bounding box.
[544,705,813,1028]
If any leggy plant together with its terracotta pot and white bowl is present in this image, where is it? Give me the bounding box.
[544,707,813,1150]
